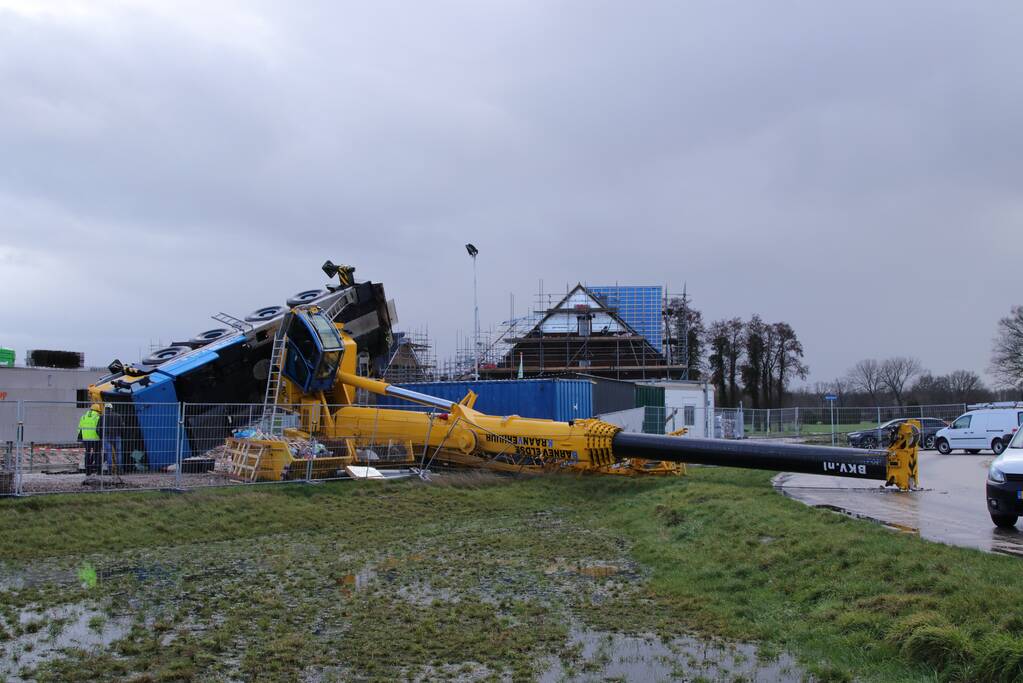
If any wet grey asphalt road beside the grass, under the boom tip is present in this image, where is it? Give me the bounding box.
[774,451,1023,557]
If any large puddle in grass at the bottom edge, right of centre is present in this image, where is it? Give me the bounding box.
[539,629,805,683]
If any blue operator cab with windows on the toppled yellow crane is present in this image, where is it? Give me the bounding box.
[283,310,344,393]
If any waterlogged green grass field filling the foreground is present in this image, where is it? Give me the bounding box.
[0,468,1023,681]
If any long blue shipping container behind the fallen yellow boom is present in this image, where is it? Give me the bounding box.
[376,379,593,422]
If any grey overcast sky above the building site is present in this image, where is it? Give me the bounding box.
[0,0,1023,381]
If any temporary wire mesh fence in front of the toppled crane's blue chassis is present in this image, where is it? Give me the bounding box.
[0,401,440,495]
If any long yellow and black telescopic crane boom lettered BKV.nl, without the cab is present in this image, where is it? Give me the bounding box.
[338,343,920,490]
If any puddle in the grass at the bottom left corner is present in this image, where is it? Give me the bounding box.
[0,604,132,681]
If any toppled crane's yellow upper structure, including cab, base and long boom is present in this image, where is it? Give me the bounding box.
[221,263,920,490]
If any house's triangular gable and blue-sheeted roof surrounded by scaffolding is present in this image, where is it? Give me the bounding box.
[480,284,685,379]
